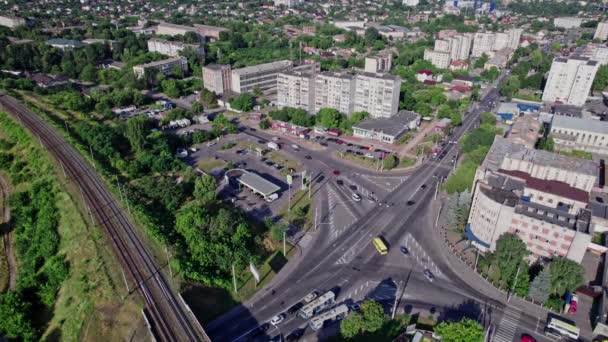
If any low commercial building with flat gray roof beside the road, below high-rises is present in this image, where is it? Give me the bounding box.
[353,110,420,144]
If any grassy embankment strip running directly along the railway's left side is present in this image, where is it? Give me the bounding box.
[0,114,147,341]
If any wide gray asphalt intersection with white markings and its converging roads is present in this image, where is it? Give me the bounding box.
[207,75,564,341]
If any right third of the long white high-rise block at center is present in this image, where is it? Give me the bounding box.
[354,72,401,118]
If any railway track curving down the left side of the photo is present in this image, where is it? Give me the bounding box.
[0,94,210,341]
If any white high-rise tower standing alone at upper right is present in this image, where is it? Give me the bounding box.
[543,57,599,106]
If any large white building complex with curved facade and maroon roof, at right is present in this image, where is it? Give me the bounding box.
[465,136,597,262]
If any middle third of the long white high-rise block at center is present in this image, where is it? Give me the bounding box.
[313,72,355,114]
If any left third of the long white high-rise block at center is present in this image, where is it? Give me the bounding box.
[277,71,315,113]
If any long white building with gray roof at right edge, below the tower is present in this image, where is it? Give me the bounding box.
[551,115,608,155]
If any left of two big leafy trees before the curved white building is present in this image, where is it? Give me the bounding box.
[491,233,528,289]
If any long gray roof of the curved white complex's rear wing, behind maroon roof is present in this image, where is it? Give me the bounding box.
[481,136,598,176]
